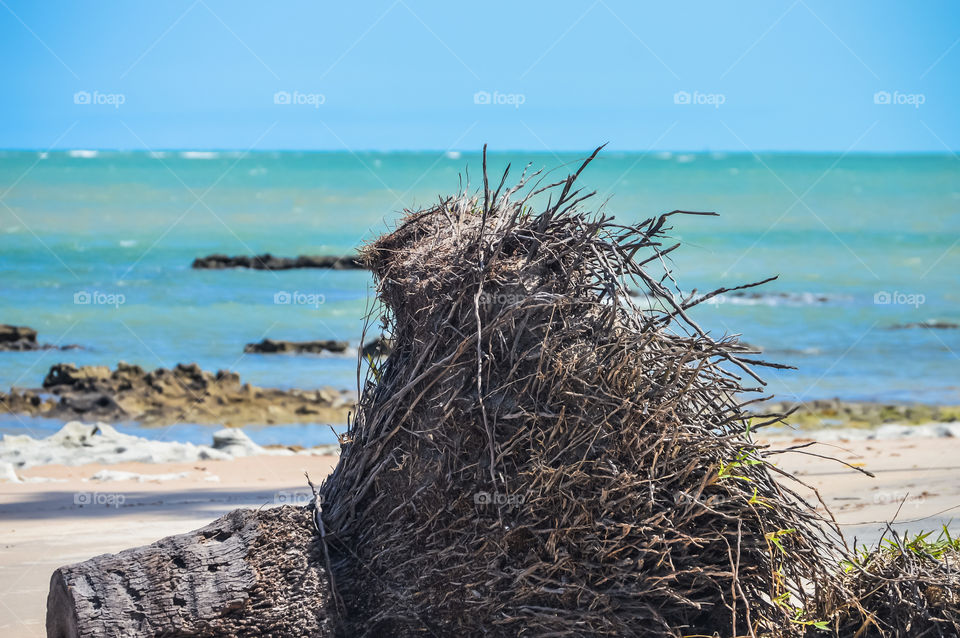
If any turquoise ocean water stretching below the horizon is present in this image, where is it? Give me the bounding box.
[0,151,960,443]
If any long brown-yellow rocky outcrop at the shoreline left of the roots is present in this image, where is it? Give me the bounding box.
[0,362,354,426]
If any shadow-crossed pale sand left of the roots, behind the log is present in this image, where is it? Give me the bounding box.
[0,456,336,638]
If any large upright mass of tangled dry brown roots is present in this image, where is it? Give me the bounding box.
[321,149,888,637]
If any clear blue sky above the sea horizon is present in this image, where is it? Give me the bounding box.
[0,0,960,152]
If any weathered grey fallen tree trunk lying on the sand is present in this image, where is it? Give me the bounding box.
[47,507,333,638]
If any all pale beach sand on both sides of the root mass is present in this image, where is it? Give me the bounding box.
[0,437,960,638]
